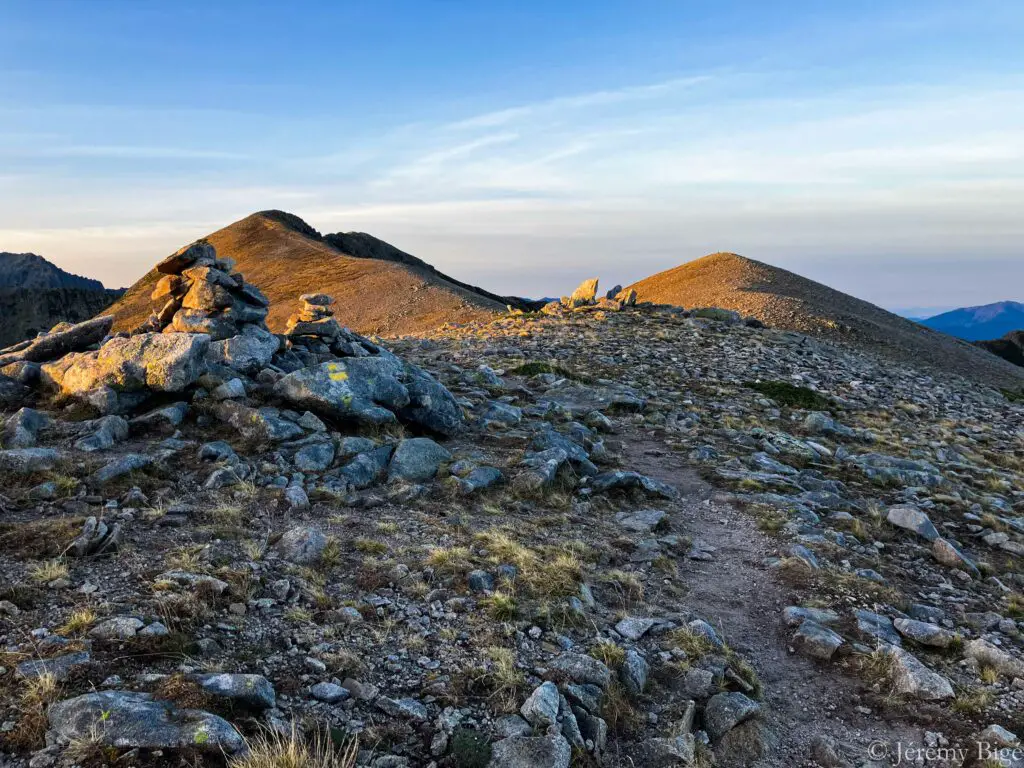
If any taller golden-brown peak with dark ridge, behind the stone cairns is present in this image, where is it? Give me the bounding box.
[103,211,505,336]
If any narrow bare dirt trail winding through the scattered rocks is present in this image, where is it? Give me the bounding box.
[623,433,922,768]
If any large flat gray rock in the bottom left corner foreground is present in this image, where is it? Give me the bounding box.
[47,691,245,755]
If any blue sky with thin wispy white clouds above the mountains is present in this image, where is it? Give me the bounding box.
[0,0,1024,308]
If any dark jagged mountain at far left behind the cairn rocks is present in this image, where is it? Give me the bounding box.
[0,252,123,347]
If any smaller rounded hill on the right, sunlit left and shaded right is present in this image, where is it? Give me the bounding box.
[630,253,1024,387]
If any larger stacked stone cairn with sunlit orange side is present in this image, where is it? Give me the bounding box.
[145,241,270,341]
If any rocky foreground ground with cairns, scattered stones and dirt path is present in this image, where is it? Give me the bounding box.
[0,266,1024,768]
